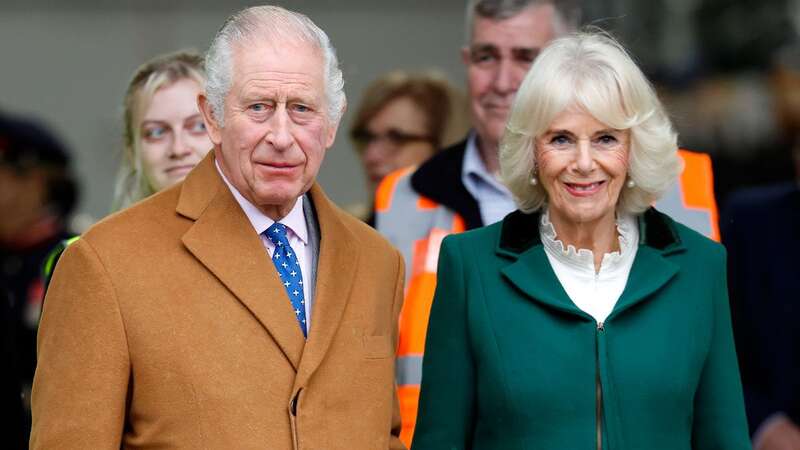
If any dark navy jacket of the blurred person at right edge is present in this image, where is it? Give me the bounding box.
[720,182,800,432]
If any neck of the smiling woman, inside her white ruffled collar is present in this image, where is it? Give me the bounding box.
[549,211,620,273]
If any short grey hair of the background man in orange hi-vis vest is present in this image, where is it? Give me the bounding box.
[464,0,580,45]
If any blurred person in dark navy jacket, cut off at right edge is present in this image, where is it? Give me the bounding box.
[720,46,800,450]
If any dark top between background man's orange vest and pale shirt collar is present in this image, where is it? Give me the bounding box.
[411,141,483,230]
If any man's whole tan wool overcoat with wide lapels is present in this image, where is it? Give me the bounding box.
[31,152,404,450]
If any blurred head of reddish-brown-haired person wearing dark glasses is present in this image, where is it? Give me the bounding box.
[350,70,467,226]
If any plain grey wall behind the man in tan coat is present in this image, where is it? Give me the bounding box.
[0,0,464,223]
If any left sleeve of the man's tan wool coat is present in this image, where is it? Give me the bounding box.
[30,239,130,449]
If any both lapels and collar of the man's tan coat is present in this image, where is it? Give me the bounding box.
[176,152,359,383]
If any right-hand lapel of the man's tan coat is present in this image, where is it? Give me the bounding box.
[295,184,359,385]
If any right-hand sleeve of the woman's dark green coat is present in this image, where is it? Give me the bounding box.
[692,247,751,450]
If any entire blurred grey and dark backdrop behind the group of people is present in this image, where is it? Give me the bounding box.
[0,0,800,225]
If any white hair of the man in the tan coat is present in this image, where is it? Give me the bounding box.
[206,6,347,126]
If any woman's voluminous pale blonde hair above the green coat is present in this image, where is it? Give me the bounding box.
[500,32,682,214]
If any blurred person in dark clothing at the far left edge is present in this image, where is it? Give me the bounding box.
[0,113,78,448]
